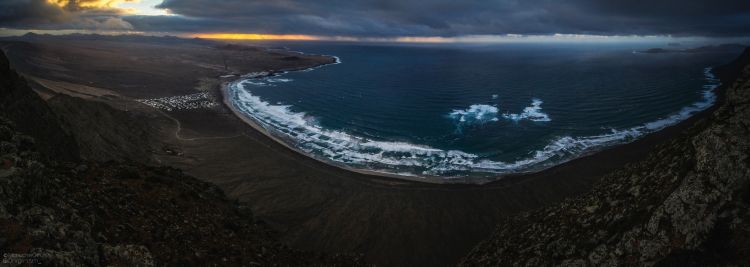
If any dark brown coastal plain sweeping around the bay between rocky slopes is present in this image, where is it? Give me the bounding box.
[0,36,748,266]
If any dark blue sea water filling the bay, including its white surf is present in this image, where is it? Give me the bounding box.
[228,43,736,179]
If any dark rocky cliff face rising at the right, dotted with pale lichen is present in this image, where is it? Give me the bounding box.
[461,49,750,266]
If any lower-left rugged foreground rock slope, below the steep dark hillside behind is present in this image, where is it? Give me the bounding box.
[0,120,358,266]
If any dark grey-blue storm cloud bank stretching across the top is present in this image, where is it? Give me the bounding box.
[0,0,750,37]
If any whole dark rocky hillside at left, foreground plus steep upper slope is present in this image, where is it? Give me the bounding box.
[0,53,360,266]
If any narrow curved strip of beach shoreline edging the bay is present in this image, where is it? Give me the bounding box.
[219,55,733,186]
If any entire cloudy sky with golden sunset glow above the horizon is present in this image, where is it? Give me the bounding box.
[0,0,750,42]
